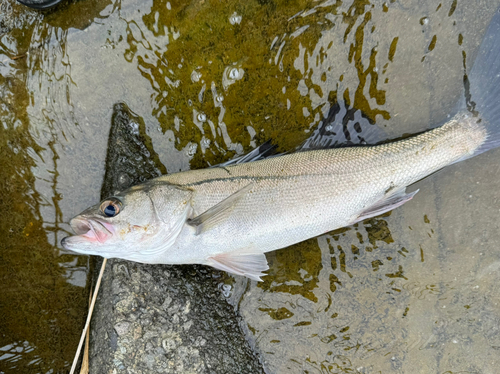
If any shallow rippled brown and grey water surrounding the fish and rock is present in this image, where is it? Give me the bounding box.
[0,0,500,373]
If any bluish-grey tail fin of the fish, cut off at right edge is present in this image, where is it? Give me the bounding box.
[464,9,500,156]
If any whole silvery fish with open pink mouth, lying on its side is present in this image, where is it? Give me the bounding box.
[62,8,500,281]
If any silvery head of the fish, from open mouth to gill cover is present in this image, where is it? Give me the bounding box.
[61,183,192,263]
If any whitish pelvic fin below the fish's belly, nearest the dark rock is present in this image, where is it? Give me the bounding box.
[206,251,269,282]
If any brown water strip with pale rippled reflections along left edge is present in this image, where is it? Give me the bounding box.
[0,1,124,373]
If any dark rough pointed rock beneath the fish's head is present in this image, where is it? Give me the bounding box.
[90,104,263,374]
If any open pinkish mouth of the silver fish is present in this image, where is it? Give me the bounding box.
[61,217,114,251]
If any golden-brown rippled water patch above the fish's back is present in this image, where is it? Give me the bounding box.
[121,1,352,162]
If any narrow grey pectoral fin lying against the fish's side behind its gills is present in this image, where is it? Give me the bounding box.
[187,182,254,235]
